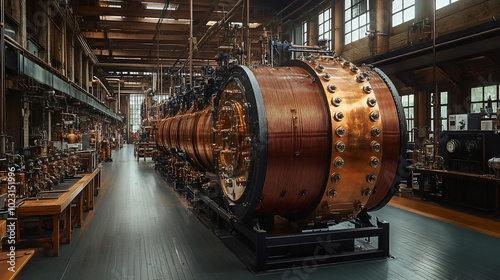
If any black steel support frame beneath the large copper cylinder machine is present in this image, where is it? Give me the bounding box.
[157,166,390,273]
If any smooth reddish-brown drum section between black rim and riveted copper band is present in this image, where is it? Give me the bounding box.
[247,67,331,215]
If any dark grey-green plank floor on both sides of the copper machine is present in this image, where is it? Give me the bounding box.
[18,145,500,280]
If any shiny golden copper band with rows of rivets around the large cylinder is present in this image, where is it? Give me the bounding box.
[292,58,390,220]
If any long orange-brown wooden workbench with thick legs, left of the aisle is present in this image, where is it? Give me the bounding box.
[16,166,102,256]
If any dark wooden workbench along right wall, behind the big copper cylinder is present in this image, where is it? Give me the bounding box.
[414,168,500,218]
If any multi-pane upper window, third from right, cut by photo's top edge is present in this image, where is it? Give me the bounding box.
[344,0,370,45]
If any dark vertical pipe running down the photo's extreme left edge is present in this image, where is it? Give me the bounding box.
[0,0,7,157]
